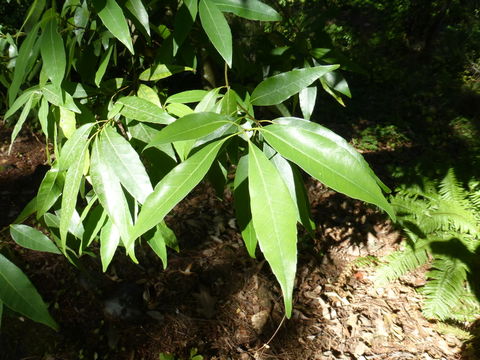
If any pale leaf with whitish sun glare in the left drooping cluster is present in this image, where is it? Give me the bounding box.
[90,138,133,248]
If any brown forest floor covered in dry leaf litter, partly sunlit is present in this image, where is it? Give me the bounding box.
[0,124,480,360]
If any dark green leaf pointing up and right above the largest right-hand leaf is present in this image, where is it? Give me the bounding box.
[251,65,339,106]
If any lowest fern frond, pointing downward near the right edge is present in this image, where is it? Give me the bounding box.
[421,257,467,320]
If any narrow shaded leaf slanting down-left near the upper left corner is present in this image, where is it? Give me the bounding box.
[8,23,40,106]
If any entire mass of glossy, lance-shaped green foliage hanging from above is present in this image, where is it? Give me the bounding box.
[0,0,394,327]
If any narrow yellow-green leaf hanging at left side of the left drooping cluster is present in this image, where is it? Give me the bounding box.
[60,141,88,252]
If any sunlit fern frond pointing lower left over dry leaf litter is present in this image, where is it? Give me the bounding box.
[374,241,429,285]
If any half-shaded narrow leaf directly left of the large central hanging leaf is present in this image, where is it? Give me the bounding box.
[233,155,258,258]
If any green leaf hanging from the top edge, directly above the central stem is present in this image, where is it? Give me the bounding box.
[199,0,232,67]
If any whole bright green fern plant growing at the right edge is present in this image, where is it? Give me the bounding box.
[375,169,480,321]
